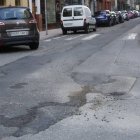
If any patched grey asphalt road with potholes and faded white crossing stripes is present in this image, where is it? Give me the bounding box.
[0,18,140,140]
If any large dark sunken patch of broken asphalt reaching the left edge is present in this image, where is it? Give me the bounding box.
[0,84,91,137]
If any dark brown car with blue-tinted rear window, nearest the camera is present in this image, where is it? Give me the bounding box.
[0,6,39,49]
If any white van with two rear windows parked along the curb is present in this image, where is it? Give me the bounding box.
[61,5,96,34]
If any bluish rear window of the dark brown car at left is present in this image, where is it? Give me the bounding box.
[0,8,32,20]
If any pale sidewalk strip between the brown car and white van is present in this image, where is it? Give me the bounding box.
[40,28,62,40]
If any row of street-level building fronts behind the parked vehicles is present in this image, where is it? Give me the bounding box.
[0,0,133,31]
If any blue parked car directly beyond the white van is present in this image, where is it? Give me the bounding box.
[95,10,114,26]
